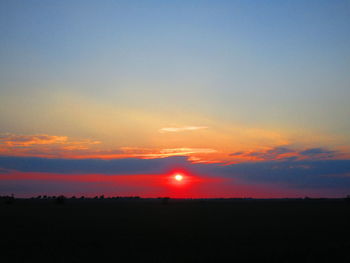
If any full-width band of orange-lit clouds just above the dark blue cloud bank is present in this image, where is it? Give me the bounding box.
[0,130,349,165]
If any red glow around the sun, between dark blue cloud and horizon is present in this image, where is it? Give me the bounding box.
[0,169,340,198]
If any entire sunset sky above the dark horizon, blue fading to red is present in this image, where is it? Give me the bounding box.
[0,0,350,198]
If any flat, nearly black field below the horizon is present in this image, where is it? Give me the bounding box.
[0,199,350,263]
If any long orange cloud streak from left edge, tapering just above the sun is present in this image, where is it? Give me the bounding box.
[0,134,217,159]
